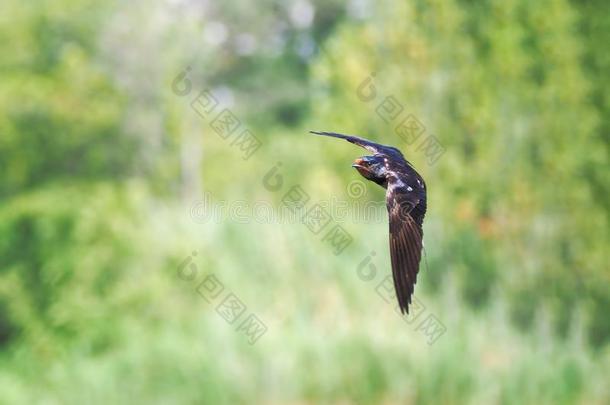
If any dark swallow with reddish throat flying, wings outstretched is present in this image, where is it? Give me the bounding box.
[310,131,426,314]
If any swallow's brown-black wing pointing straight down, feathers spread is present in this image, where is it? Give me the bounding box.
[386,179,425,313]
